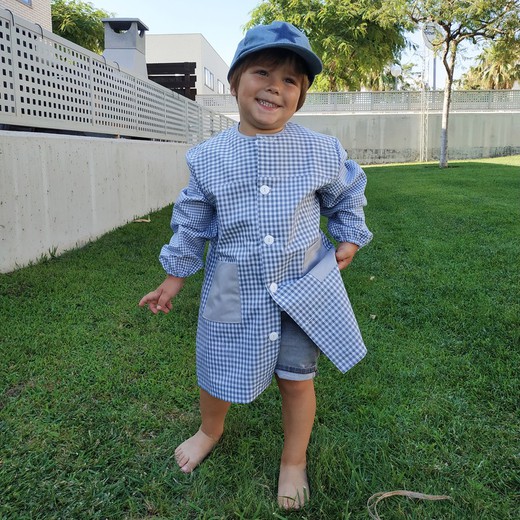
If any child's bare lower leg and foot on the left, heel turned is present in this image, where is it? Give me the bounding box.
[175,388,231,473]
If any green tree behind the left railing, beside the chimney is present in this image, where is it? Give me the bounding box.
[51,0,112,54]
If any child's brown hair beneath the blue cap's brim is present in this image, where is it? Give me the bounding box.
[229,47,310,111]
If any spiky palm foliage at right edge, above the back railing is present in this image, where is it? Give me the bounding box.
[462,40,520,90]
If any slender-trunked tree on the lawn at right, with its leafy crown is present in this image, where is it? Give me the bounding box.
[406,0,520,168]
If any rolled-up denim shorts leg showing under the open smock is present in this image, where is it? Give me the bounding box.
[274,312,320,381]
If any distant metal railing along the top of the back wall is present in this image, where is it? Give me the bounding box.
[197,90,520,114]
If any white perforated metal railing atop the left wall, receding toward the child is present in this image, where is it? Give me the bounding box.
[0,9,235,144]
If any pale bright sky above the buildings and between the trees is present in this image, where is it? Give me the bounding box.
[89,0,472,89]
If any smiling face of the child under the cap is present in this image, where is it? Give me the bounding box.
[231,62,302,135]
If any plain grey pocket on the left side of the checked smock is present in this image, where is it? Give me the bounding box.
[202,262,242,323]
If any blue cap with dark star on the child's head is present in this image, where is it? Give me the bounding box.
[228,22,323,83]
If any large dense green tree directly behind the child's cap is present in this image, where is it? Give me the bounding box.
[247,0,406,91]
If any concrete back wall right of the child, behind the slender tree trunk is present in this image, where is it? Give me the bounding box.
[294,112,520,164]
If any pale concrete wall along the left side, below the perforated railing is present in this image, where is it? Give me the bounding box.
[0,131,188,272]
